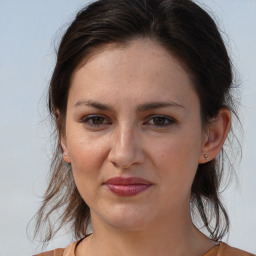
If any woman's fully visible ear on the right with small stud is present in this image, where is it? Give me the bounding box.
[199,108,231,164]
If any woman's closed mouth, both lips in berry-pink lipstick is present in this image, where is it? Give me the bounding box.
[104,177,153,197]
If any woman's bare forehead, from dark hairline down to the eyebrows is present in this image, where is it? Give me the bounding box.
[70,39,200,108]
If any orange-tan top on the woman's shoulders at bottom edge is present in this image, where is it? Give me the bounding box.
[34,241,256,256]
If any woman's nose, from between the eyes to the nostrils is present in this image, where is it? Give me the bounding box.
[108,126,144,169]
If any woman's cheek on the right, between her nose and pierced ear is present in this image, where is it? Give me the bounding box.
[150,126,201,191]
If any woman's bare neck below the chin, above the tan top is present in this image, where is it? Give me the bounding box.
[77,208,215,256]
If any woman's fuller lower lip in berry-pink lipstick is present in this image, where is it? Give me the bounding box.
[106,184,151,196]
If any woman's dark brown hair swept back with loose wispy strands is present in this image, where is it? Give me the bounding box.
[35,0,239,242]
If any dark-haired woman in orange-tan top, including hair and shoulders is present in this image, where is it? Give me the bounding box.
[33,0,252,256]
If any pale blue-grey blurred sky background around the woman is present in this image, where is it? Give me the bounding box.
[0,0,256,256]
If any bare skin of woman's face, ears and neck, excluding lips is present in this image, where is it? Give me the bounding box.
[62,39,230,256]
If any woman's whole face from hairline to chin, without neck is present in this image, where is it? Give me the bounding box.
[62,39,208,230]
